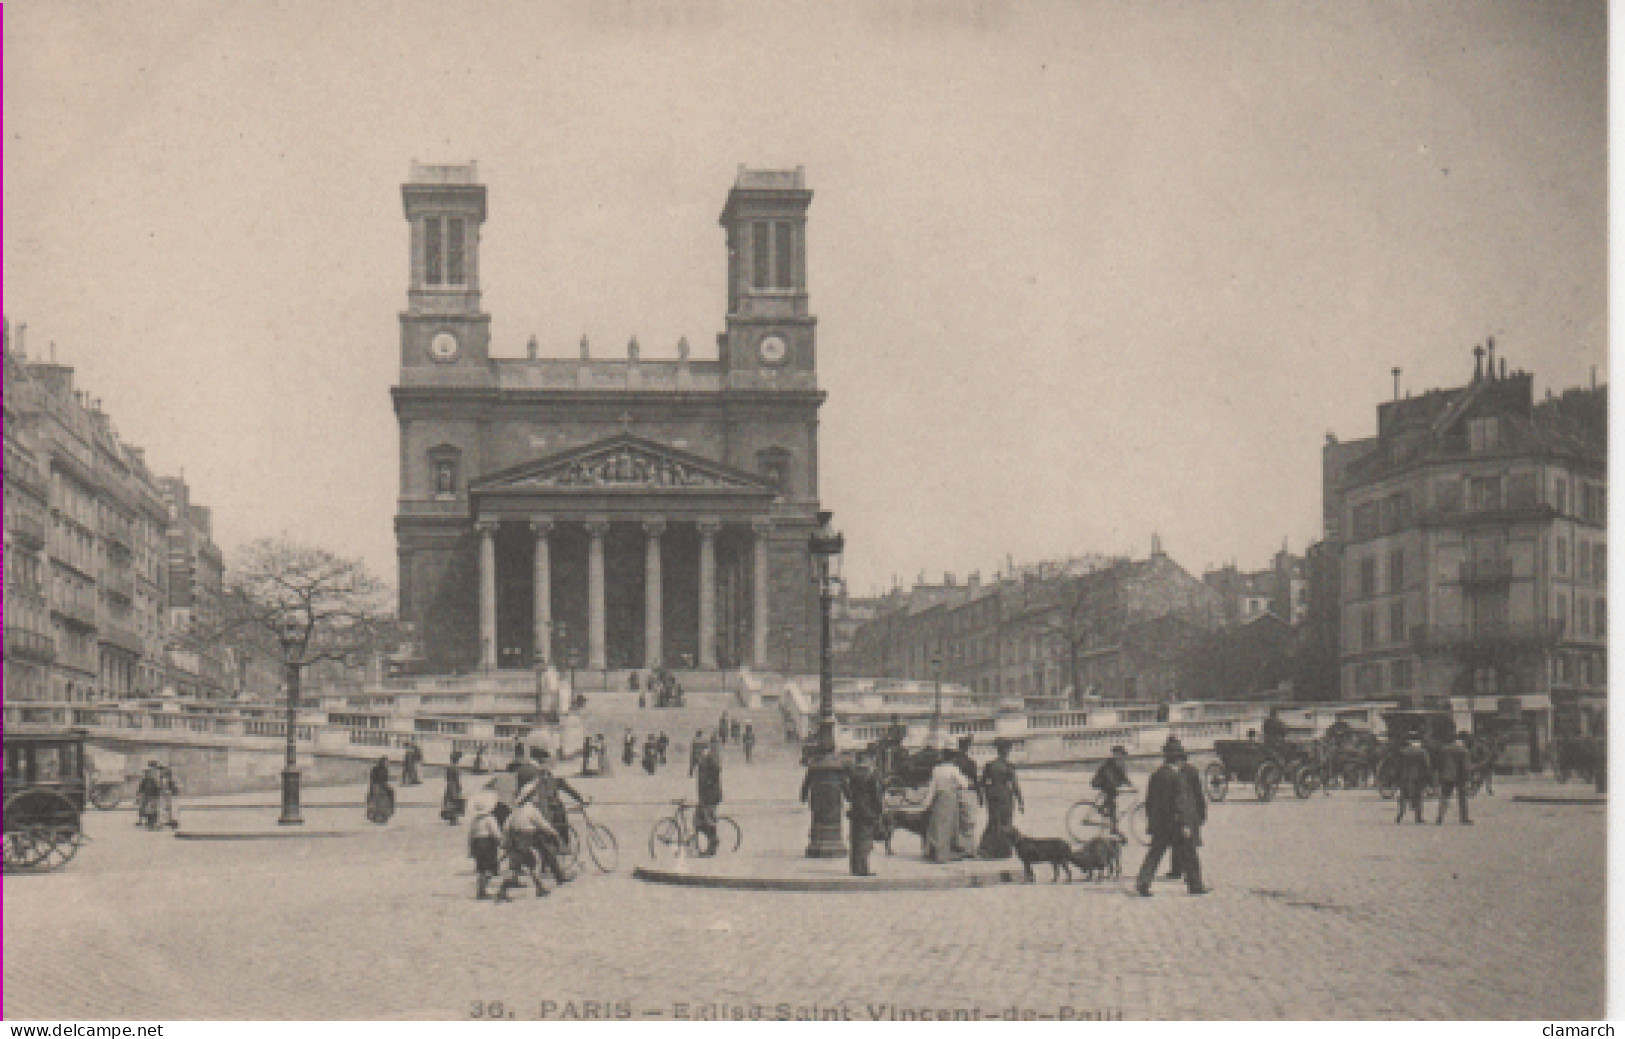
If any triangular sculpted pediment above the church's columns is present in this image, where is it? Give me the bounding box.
[470,433,778,498]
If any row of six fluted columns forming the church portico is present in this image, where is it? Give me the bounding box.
[475,514,774,670]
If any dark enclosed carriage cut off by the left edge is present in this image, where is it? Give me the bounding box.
[3,725,86,870]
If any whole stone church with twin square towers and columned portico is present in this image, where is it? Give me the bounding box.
[392,164,824,673]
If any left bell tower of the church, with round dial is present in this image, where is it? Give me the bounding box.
[401,163,491,372]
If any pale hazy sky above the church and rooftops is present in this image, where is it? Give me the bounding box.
[3,0,1607,593]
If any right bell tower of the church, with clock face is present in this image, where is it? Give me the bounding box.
[717,166,817,389]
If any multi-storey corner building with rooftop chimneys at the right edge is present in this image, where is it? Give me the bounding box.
[1328,341,1607,758]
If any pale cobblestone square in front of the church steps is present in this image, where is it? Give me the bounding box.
[5,761,1606,1019]
